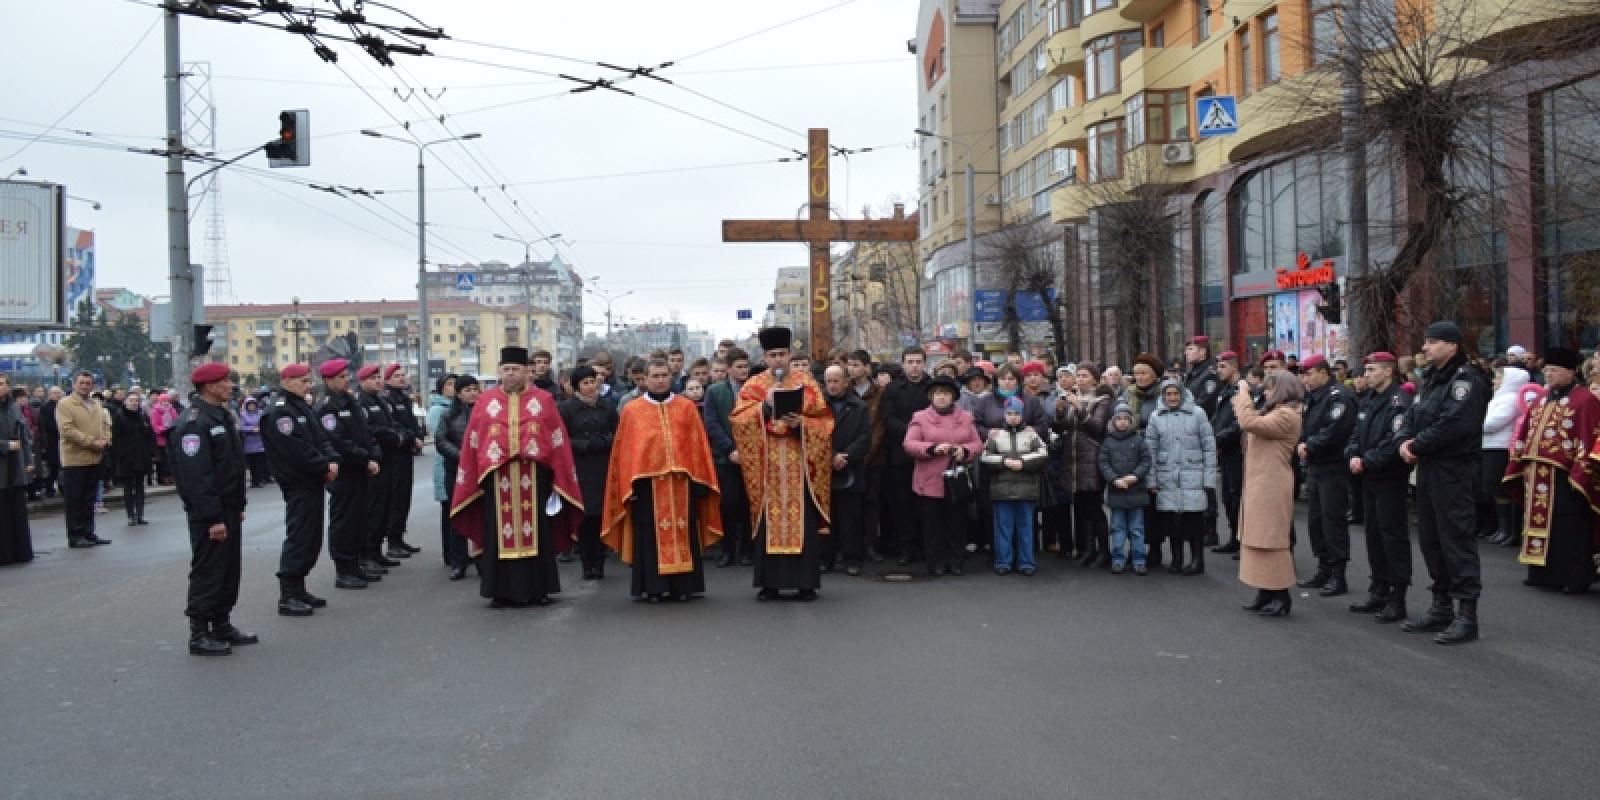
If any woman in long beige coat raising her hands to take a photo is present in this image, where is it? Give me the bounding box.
[1234,371,1306,616]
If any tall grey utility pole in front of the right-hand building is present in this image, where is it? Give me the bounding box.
[1344,0,1369,349]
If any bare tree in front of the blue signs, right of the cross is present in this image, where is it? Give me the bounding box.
[979,218,1066,363]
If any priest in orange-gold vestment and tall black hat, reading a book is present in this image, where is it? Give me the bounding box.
[730,328,834,602]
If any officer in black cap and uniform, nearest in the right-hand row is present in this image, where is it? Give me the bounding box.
[1400,320,1490,645]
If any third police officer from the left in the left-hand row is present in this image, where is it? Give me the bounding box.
[317,358,382,589]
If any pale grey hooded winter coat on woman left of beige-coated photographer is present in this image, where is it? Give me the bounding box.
[1144,379,1216,512]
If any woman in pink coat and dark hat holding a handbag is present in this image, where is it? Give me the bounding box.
[906,378,984,574]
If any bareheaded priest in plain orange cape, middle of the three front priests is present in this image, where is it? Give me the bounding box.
[600,358,722,603]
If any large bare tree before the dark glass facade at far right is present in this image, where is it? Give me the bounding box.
[1259,0,1600,352]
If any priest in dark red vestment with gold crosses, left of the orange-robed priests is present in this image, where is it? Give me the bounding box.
[450,347,584,608]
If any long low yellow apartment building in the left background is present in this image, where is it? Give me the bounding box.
[206,299,555,384]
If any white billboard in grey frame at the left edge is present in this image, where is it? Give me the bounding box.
[0,181,67,330]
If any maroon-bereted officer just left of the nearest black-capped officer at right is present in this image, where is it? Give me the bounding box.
[1344,350,1411,622]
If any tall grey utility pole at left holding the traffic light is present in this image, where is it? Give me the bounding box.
[163,10,202,395]
